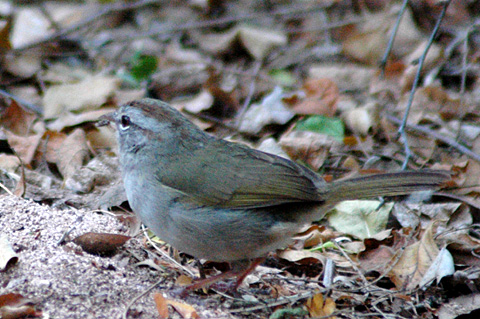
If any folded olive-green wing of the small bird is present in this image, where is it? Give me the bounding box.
[157,140,325,209]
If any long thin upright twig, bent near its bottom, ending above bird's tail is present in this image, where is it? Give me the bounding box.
[398,0,451,169]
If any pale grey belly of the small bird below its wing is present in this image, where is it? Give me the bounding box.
[124,175,312,261]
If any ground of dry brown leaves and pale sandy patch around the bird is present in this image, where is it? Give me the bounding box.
[0,0,480,318]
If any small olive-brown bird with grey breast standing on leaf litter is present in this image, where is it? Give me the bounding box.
[99,98,450,289]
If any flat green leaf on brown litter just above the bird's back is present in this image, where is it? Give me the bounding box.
[295,115,345,141]
